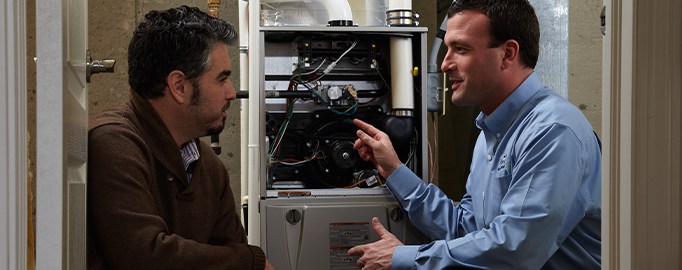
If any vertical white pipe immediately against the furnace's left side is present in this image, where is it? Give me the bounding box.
[247,0,261,246]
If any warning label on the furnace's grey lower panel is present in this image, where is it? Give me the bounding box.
[329,222,370,270]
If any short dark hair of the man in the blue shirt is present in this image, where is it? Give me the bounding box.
[448,0,540,68]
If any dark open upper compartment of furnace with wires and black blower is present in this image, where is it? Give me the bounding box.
[261,27,426,194]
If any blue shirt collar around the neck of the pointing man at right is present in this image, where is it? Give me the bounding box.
[476,71,543,136]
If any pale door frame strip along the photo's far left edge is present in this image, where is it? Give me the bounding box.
[0,0,30,269]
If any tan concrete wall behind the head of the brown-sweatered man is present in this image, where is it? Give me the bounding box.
[88,0,241,208]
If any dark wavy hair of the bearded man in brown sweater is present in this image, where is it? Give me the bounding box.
[128,6,237,99]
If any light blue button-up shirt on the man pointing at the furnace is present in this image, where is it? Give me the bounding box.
[387,73,601,269]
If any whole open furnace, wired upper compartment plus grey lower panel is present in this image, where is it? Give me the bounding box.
[259,27,427,270]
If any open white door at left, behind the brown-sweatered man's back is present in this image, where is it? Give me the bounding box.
[36,0,88,269]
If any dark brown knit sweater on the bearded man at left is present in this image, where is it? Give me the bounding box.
[87,91,265,270]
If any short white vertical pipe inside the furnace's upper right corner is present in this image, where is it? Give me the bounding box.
[390,37,414,109]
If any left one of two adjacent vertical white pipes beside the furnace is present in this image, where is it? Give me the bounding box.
[239,1,249,226]
